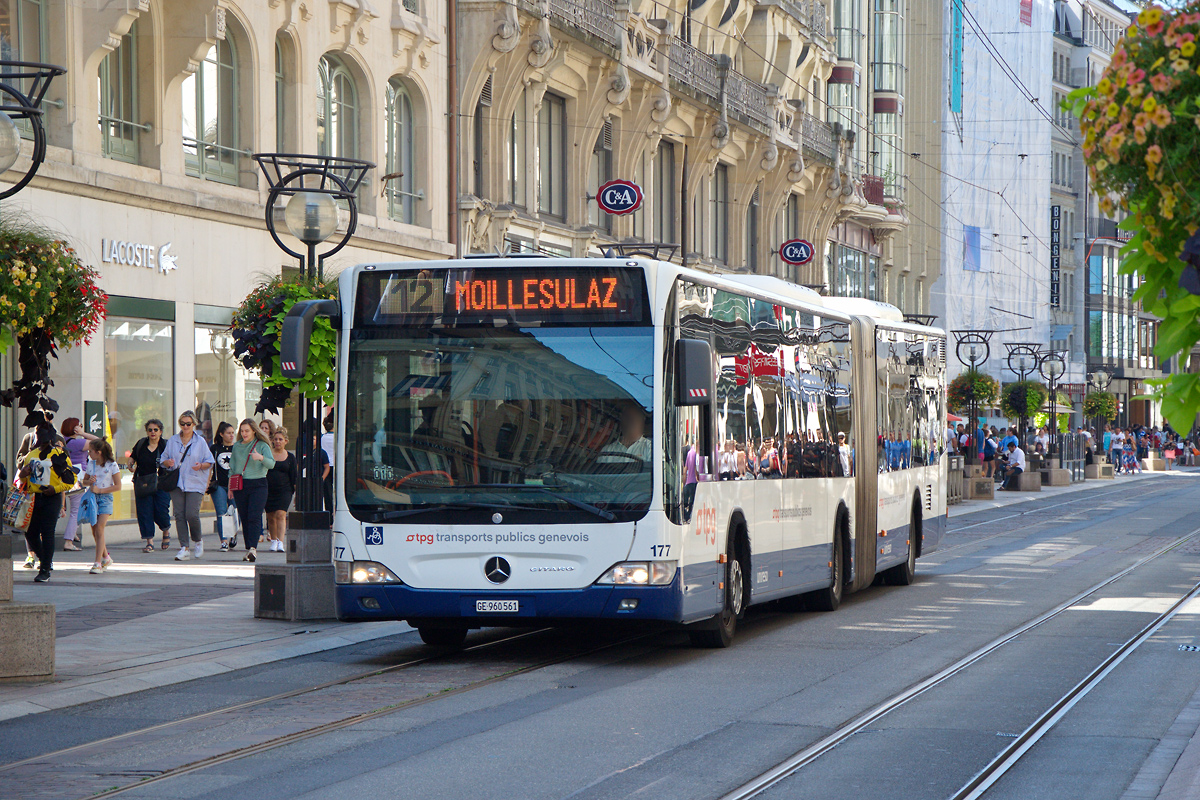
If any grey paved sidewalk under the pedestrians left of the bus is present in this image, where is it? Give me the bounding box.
[0,535,412,720]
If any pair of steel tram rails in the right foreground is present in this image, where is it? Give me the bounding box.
[720,528,1200,800]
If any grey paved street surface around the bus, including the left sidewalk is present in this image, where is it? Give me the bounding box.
[0,471,1200,800]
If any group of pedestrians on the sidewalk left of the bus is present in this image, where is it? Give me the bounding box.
[9,410,334,583]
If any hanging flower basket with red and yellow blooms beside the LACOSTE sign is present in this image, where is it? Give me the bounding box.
[0,217,108,427]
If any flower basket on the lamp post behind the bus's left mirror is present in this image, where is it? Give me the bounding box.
[230,278,337,414]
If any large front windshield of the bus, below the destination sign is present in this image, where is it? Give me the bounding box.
[344,326,654,524]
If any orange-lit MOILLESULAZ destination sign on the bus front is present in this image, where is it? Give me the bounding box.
[358,265,648,325]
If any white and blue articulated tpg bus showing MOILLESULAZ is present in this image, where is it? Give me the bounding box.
[283,257,947,646]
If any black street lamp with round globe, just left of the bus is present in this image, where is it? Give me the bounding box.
[253,152,374,520]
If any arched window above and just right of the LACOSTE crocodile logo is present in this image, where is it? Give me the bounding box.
[184,40,241,184]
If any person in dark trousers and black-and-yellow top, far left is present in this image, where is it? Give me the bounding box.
[17,422,76,583]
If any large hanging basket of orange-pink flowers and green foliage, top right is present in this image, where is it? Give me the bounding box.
[1064,0,1200,431]
